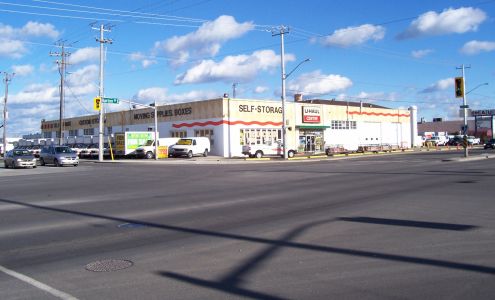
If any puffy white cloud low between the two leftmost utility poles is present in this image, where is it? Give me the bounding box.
[9,84,59,104]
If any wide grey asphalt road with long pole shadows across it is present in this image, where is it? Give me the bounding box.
[0,151,495,299]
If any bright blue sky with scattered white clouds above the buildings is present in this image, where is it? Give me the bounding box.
[0,0,495,137]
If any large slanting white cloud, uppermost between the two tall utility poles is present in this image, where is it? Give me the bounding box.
[155,16,254,63]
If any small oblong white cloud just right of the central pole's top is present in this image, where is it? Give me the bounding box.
[321,24,385,47]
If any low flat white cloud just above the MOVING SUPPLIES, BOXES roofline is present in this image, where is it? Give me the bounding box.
[135,87,219,104]
